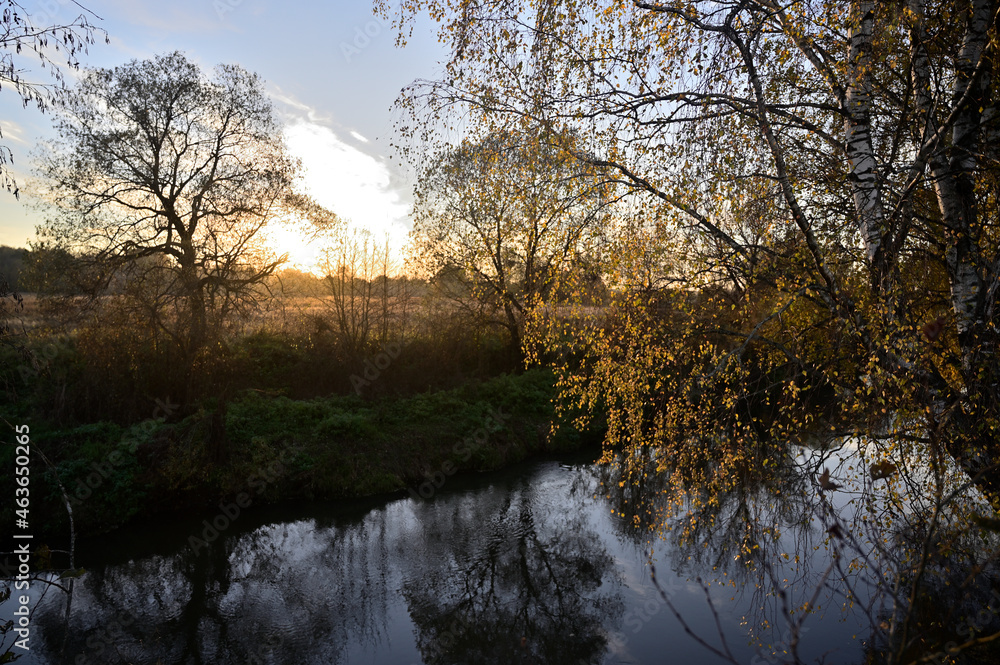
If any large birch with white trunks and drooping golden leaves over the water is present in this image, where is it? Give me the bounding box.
[386,0,1000,662]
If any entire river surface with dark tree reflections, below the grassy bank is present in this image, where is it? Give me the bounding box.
[9,440,1000,665]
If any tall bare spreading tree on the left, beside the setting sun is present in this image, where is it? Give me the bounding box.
[39,52,310,357]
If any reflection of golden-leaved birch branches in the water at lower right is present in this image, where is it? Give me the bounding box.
[600,440,1000,663]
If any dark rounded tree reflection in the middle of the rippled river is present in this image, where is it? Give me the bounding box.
[403,484,624,665]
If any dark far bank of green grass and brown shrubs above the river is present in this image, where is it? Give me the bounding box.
[0,299,601,537]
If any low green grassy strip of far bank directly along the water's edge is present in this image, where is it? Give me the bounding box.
[3,369,601,537]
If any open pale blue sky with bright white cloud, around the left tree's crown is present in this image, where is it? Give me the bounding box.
[0,0,445,270]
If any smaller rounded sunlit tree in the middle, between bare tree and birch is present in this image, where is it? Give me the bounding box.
[411,130,612,353]
